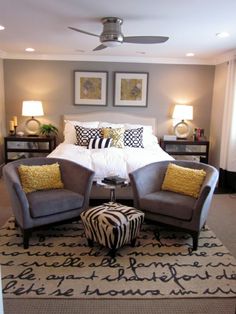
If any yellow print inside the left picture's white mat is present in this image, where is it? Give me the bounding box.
[80,77,102,100]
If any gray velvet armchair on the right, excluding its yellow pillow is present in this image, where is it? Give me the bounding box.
[129,160,218,250]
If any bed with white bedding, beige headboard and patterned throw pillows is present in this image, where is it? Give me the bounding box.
[48,111,173,198]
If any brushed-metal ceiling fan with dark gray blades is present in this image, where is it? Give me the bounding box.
[68,17,169,51]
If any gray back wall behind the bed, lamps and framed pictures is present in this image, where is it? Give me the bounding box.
[4,60,215,141]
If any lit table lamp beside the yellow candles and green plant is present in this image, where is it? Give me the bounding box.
[22,100,44,136]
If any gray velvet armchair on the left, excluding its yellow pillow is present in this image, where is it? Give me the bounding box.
[3,157,94,248]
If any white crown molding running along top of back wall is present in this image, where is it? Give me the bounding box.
[3,53,218,65]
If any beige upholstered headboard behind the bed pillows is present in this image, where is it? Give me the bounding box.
[63,111,157,135]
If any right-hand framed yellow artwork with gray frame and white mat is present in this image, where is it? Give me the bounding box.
[114,72,148,107]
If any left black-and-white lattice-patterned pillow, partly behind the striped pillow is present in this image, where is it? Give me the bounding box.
[75,125,102,147]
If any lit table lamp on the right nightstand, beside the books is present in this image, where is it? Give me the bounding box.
[172,104,193,139]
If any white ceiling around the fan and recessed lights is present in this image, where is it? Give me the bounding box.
[0,0,236,64]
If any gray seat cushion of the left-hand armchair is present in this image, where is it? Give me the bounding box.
[27,189,84,218]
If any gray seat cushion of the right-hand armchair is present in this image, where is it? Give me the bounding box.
[140,191,196,220]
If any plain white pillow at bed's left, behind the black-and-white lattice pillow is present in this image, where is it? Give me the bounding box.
[63,120,99,144]
